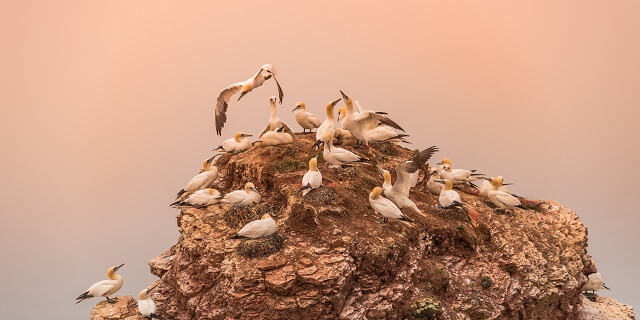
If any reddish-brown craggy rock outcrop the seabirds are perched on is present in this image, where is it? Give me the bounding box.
[95,135,636,320]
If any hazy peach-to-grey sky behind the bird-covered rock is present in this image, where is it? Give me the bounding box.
[0,1,640,319]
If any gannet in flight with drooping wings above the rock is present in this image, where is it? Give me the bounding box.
[216,64,284,135]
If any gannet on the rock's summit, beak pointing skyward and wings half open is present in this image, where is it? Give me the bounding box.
[340,91,404,146]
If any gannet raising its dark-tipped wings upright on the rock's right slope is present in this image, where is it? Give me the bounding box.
[384,146,438,213]
